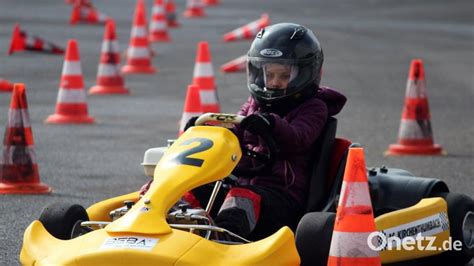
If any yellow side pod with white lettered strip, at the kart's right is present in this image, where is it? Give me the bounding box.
[374,198,449,263]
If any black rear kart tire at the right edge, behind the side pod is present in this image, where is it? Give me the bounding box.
[418,193,474,266]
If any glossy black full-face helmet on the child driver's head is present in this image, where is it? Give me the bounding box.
[247,23,323,111]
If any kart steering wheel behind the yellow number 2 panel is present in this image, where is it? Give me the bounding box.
[194,113,277,177]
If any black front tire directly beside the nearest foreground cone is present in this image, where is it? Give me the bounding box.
[296,212,336,266]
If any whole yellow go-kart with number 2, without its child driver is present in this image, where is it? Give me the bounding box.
[20,114,474,265]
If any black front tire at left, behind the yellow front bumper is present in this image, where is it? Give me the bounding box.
[39,202,89,240]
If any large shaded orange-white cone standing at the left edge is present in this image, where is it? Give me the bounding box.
[0,83,51,194]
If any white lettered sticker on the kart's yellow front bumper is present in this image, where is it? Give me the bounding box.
[100,236,159,251]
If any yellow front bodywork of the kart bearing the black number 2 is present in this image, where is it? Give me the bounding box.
[20,126,300,266]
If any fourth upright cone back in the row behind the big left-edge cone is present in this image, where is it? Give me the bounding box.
[149,0,171,42]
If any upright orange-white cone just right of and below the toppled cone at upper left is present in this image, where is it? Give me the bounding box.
[45,40,95,124]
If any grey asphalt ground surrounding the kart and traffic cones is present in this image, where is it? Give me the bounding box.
[0,0,474,265]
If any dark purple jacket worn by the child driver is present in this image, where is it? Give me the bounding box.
[237,87,346,206]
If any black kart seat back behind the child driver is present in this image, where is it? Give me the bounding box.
[306,117,337,212]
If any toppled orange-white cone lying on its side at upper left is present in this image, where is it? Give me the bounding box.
[8,23,64,55]
